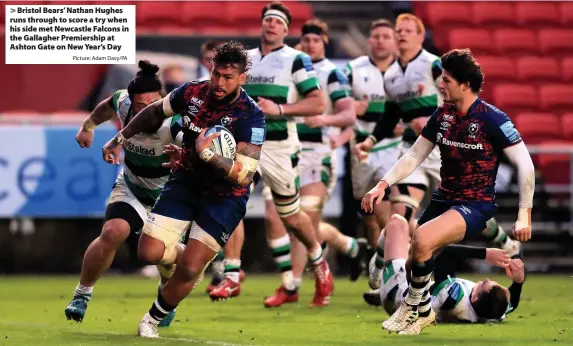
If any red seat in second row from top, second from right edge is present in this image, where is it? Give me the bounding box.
[493,29,537,55]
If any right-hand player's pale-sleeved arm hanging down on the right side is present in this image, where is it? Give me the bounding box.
[503,141,535,241]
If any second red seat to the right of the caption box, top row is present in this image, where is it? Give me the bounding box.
[181,1,231,29]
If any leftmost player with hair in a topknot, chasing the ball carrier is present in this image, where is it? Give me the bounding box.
[65,61,182,326]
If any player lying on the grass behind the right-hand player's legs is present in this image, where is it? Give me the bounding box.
[379,222,525,334]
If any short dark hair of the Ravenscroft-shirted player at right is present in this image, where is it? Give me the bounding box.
[441,48,484,94]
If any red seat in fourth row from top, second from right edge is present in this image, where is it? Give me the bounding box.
[493,84,538,114]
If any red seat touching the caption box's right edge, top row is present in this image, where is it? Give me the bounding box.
[136,1,182,28]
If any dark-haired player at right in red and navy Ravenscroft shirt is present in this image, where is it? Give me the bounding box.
[362,49,535,334]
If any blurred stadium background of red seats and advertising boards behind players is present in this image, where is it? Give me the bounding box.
[0,1,573,272]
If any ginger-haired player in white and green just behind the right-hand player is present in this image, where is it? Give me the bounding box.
[356,13,520,305]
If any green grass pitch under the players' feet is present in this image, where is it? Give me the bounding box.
[0,275,573,346]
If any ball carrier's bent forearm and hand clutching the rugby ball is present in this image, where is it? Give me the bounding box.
[195,129,261,187]
